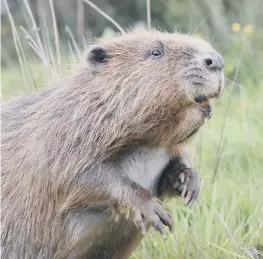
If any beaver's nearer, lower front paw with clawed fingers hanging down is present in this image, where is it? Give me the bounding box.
[131,198,173,237]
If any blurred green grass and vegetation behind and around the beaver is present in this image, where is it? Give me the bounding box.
[1,0,263,259]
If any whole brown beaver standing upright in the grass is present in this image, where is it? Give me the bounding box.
[1,30,224,259]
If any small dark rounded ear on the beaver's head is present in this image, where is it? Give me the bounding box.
[86,45,108,65]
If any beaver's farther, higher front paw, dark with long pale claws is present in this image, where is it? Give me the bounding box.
[173,168,201,206]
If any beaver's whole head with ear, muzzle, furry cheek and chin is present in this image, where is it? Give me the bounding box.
[84,30,224,147]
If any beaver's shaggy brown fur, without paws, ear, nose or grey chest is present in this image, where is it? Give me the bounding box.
[1,28,225,258]
